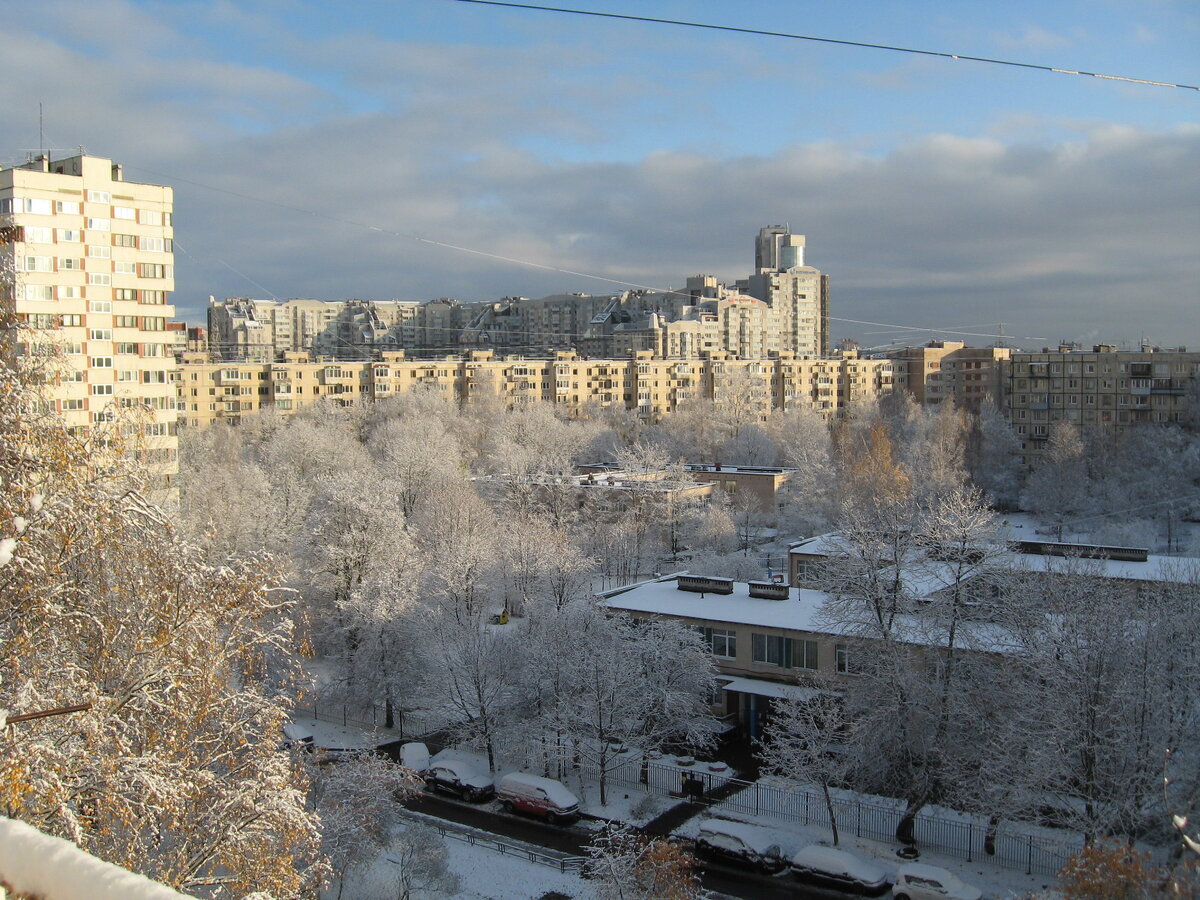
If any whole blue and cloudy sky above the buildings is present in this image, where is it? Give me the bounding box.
[0,0,1200,349]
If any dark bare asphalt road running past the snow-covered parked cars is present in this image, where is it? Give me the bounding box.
[404,793,868,900]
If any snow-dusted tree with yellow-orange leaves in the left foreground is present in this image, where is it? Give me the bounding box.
[0,303,322,898]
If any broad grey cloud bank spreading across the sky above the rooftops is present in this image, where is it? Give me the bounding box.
[0,4,1200,344]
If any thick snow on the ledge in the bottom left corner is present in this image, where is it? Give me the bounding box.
[0,816,190,900]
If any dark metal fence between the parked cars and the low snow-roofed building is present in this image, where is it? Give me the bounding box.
[578,760,1084,875]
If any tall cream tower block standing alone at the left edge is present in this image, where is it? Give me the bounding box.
[0,154,178,481]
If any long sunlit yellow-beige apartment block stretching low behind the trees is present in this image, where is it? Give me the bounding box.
[178,350,892,426]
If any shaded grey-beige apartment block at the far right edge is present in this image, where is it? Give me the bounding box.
[1003,344,1200,464]
